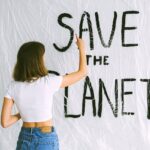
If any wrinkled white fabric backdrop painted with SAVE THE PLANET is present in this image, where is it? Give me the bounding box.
[0,0,150,150]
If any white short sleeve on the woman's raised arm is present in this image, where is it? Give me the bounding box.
[49,75,63,92]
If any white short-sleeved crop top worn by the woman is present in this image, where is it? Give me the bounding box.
[4,74,63,122]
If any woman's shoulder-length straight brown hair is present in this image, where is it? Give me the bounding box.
[13,41,48,82]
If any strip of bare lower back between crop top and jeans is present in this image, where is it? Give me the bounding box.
[22,119,53,128]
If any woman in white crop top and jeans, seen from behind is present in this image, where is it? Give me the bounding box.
[1,33,87,150]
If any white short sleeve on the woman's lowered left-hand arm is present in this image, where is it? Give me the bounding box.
[4,81,14,99]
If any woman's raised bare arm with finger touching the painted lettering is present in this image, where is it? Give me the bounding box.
[60,36,88,88]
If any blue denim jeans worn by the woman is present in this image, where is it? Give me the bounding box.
[16,126,59,150]
